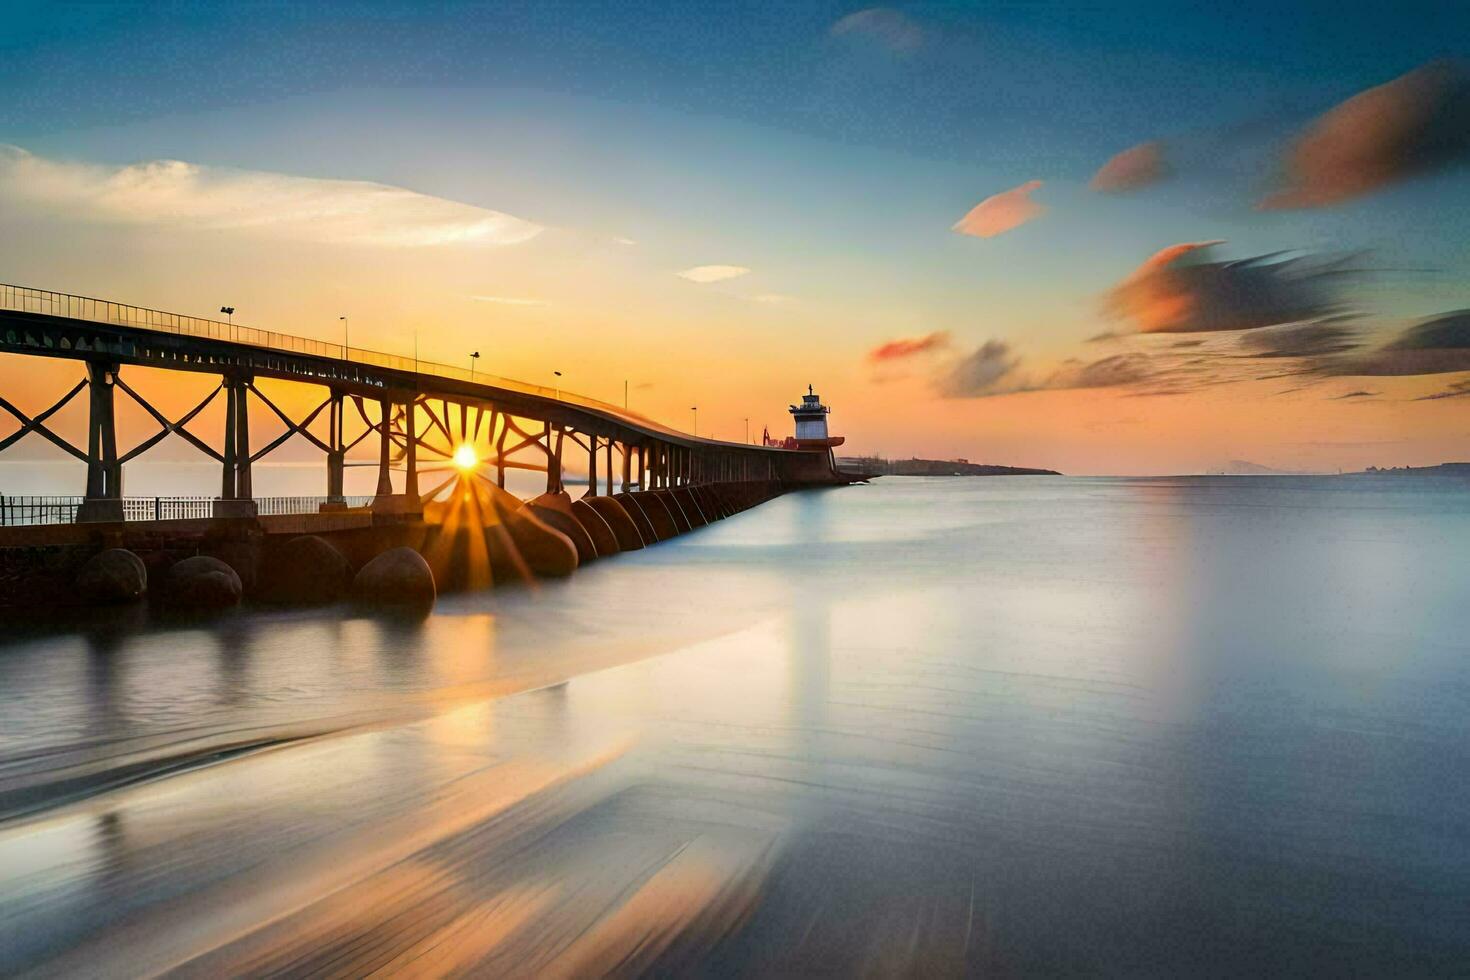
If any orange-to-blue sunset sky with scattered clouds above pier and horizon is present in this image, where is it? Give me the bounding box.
[0,1,1470,473]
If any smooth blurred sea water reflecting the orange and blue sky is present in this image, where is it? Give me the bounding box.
[0,478,1470,976]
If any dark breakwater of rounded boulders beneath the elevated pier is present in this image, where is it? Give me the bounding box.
[0,479,792,610]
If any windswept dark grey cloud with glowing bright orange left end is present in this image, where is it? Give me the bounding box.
[1104,241,1355,334]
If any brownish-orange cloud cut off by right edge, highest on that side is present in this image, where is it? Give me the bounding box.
[1260,60,1470,209]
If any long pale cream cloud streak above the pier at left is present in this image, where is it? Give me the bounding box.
[0,145,542,248]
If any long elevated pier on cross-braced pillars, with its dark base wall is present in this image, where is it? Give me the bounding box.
[0,285,861,604]
